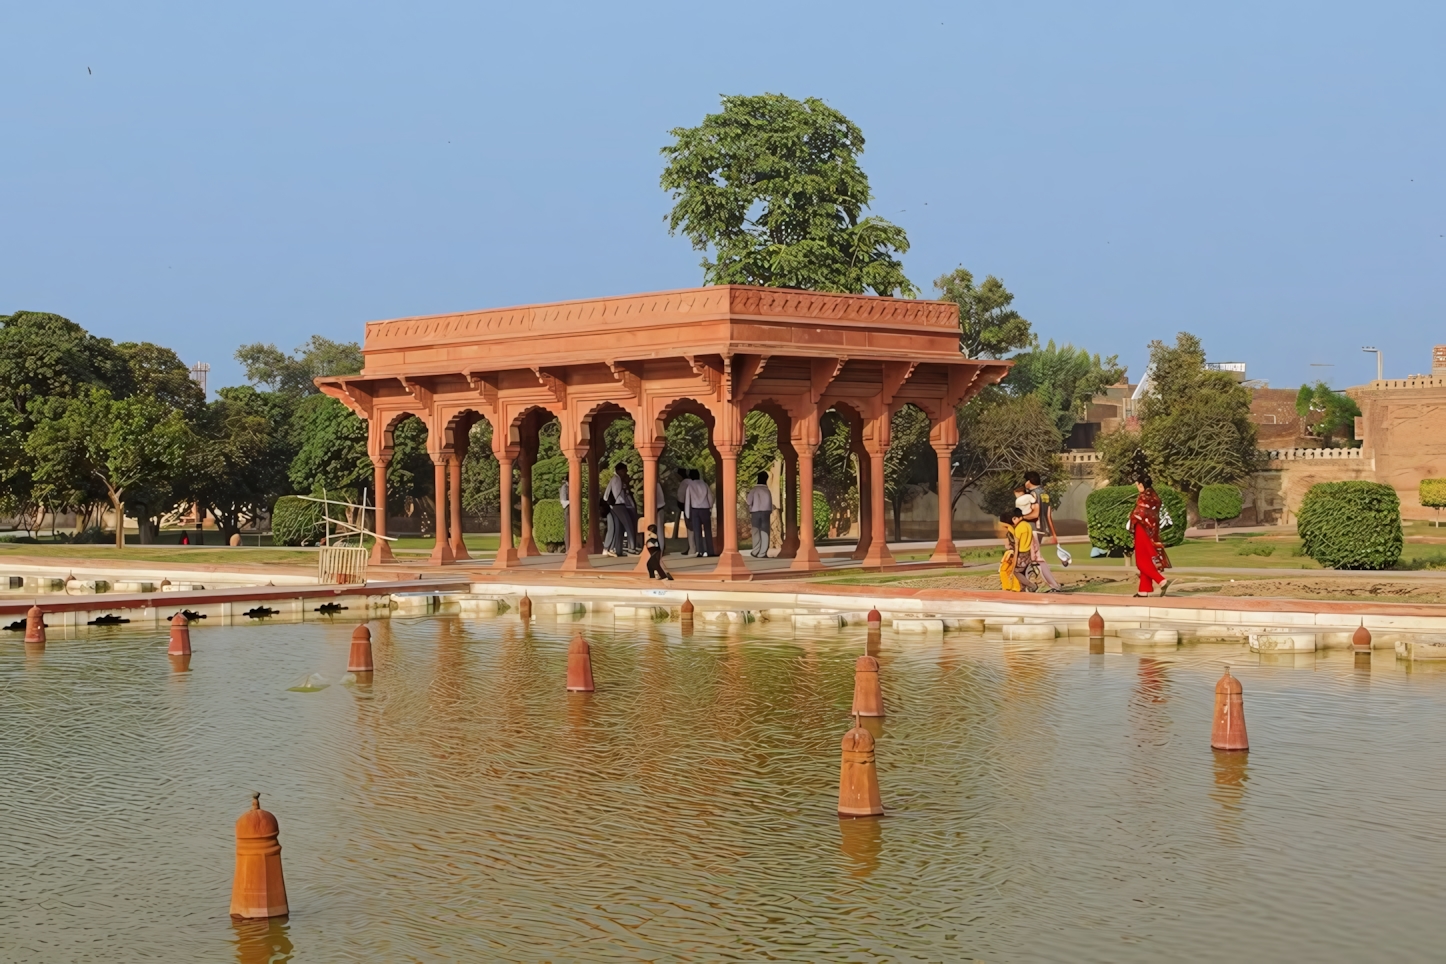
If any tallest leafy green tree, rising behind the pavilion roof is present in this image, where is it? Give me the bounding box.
[661,94,917,298]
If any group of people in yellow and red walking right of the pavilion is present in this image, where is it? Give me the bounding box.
[999,467,1170,595]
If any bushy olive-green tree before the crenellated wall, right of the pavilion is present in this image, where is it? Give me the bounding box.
[1098,332,1259,512]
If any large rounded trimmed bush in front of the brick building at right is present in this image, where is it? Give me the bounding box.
[1296,481,1403,569]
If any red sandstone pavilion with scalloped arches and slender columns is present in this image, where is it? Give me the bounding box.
[317,285,1009,580]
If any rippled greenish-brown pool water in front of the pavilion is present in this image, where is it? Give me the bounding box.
[0,617,1446,963]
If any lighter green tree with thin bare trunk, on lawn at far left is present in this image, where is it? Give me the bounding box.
[25,386,191,549]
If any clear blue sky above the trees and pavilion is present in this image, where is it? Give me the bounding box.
[0,1,1446,387]
